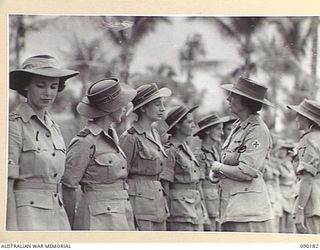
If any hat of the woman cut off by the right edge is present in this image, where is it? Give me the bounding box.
[287,99,320,126]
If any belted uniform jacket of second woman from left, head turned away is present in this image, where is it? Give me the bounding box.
[62,122,134,230]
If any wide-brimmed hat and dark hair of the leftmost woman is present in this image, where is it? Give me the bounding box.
[9,55,79,97]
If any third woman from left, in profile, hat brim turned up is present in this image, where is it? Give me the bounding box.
[120,83,171,231]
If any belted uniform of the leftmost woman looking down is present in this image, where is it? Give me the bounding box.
[8,103,70,230]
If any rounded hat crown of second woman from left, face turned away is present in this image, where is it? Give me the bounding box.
[87,78,121,104]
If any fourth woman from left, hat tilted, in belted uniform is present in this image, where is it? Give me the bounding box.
[161,105,207,231]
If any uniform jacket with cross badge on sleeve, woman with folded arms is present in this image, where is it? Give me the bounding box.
[220,114,272,223]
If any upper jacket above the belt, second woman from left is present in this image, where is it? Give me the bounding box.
[62,122,128,188]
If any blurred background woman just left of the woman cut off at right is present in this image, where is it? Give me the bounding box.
[277,140,297,233]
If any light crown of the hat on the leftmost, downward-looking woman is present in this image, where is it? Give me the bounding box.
[22,55,58,69]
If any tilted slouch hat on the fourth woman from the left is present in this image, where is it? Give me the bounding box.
[161,105,199,134]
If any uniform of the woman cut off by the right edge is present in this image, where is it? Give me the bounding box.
[296,129,320,217]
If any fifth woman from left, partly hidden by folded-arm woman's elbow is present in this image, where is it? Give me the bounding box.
[194,113,229,231]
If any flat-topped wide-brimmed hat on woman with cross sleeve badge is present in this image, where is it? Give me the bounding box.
[221,77,273,106]
